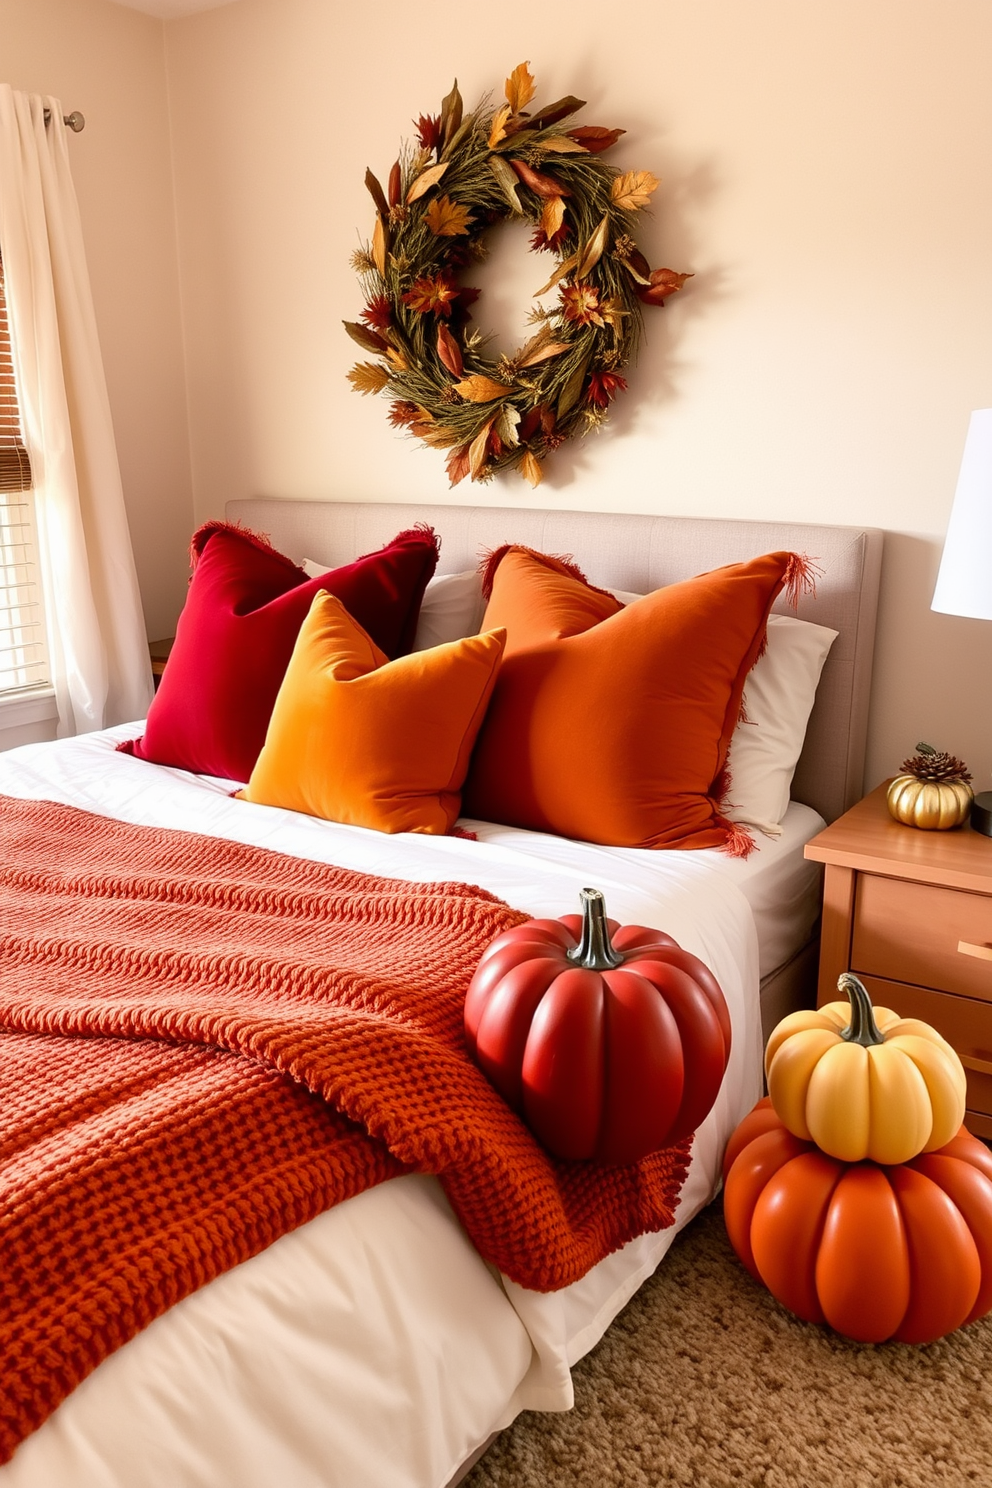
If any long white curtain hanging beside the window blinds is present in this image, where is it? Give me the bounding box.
[0,83,152,735]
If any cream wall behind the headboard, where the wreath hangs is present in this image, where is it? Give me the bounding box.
[165,0,992,789]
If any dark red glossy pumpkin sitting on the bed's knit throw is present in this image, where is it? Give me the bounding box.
[466,888,730,1162]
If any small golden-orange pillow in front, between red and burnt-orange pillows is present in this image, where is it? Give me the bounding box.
[238,591,504,833]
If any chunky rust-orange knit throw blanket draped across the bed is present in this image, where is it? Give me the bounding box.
[0,796,689,1461]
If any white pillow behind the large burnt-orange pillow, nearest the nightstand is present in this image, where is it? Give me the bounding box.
[611,589,839,836]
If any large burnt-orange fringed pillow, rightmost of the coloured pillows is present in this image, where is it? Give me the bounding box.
[464,549,806,854]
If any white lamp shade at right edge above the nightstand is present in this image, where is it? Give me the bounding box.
[931,408,992,620]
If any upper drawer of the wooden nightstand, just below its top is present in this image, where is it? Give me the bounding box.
[851,873,992,1005]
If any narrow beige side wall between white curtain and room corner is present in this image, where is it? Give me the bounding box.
[0,0,193,642]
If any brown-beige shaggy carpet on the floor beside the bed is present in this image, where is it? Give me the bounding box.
[464,1202,992,1488]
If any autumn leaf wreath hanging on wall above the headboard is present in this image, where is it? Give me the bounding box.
[345,62,690,487]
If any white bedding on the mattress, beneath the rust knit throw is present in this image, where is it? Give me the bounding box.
[0,725,819,1488]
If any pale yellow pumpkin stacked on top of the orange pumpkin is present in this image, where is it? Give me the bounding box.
[764,972,965,1164]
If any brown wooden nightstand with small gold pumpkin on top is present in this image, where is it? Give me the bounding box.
[806,786,992,1137]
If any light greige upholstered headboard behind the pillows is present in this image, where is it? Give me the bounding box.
[228,500,882,821]
